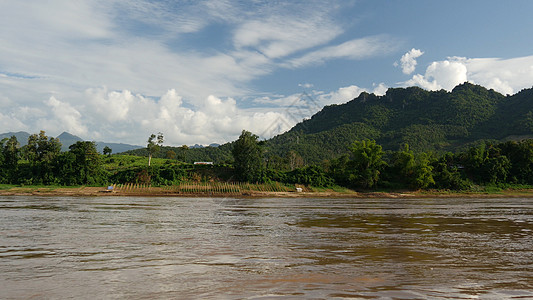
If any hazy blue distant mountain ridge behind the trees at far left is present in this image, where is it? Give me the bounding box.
[0,131,143,153]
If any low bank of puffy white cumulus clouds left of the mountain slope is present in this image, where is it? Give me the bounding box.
[81,88,295,145]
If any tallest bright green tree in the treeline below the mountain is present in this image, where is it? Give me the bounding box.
[348,139,386,188]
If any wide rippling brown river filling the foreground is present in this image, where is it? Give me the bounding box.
[0,196,533,299]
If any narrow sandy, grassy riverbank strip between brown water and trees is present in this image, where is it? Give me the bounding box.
[0,186,533,198]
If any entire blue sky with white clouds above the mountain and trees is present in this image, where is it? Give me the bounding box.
[0,0,533,145]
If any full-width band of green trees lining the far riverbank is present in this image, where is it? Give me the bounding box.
[0,131,533,190]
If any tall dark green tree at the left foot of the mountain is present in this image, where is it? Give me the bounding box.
[231,130,265,182]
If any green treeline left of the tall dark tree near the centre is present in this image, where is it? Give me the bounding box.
[0,131,233,186]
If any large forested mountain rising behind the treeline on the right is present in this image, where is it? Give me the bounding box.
[128,83,533,164]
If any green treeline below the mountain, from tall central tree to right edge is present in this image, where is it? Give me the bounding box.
[233,131,533,190]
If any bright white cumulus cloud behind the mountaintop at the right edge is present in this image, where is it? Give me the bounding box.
[402,56,533,94]
